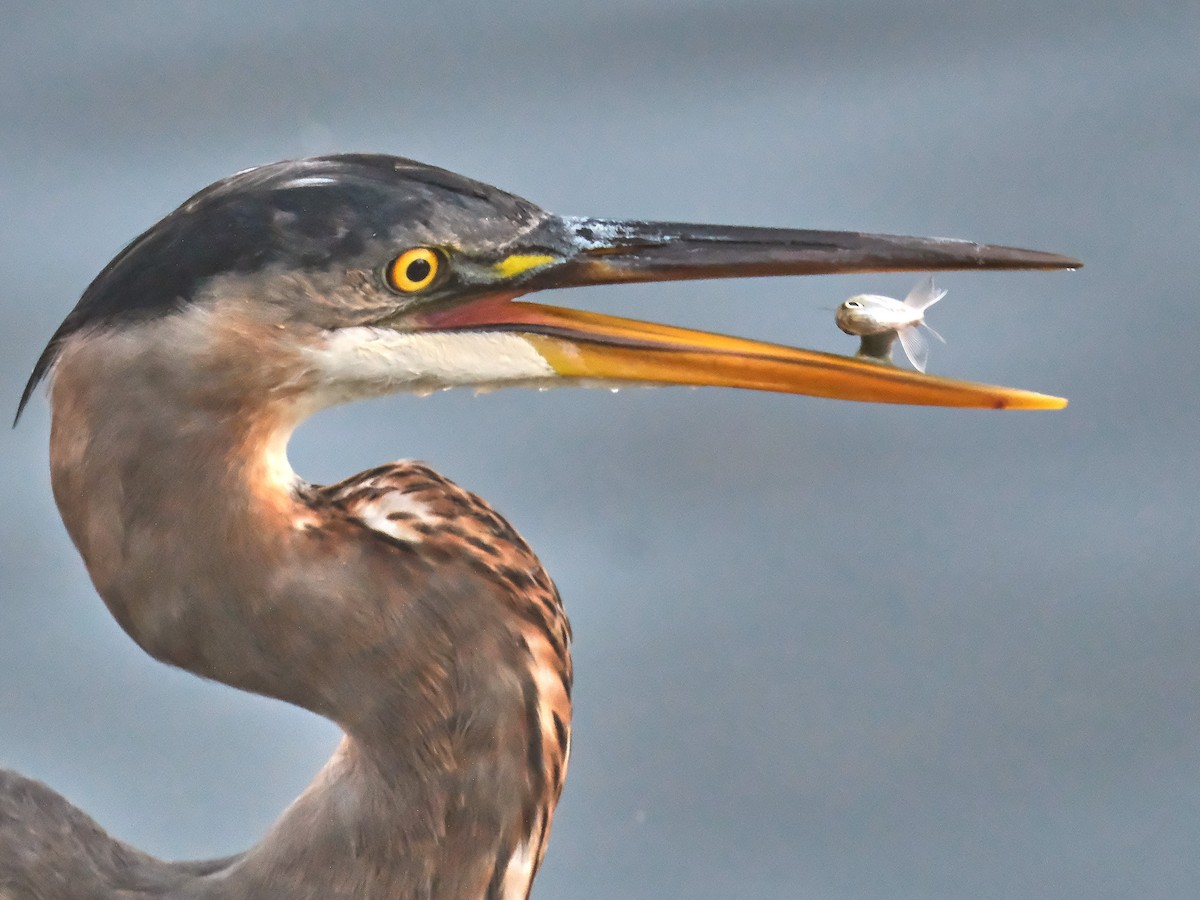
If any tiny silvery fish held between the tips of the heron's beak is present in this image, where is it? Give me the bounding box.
[835,275,946,372]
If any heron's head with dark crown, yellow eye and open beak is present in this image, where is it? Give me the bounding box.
[18,155,1078,415]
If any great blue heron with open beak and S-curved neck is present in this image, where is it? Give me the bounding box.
[0,155,1078,900]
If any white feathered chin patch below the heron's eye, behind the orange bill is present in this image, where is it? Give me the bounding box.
[308,326,558,402]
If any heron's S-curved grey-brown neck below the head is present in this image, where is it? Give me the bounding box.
[50,321,570,900]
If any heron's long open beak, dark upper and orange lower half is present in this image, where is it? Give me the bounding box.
[418,217,1081,409]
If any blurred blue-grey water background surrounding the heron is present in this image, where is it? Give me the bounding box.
[0,0,1200,898]
